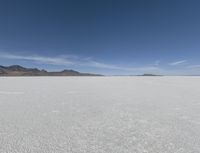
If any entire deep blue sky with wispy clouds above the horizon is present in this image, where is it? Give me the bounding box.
[0,0,200,75]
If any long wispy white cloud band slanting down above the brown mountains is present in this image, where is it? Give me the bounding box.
[0,53,160,73]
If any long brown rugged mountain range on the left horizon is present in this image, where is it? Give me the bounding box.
[0,65,101,76]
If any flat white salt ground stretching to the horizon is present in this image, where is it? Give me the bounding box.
[0,77,200,153]
